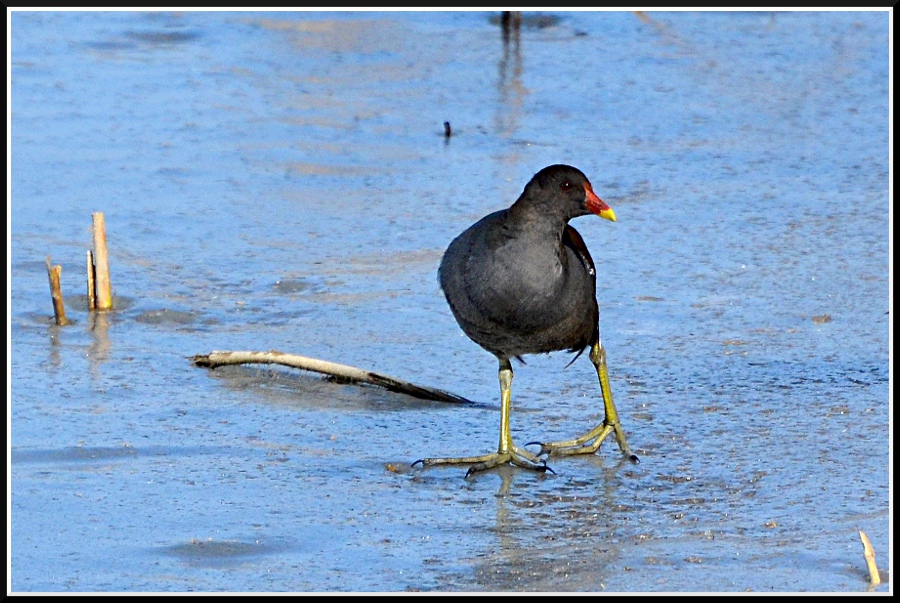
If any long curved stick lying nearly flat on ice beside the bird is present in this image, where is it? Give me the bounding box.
[191,350,473,404]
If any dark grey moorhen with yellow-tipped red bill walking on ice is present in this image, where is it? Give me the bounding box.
[413,165,637,477]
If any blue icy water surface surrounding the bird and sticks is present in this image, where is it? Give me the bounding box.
[8,11,892,593]
